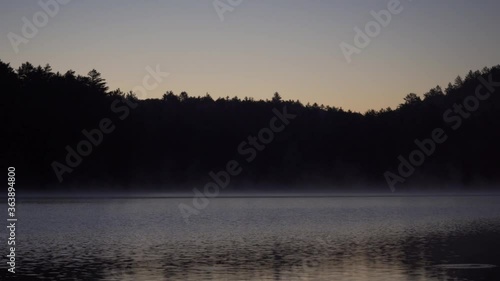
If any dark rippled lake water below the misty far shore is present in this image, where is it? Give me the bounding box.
[0,197,500,281]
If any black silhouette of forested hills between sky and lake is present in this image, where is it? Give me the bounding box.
[0,61,500,191]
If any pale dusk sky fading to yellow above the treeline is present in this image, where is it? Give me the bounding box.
[0,0,500,112]
